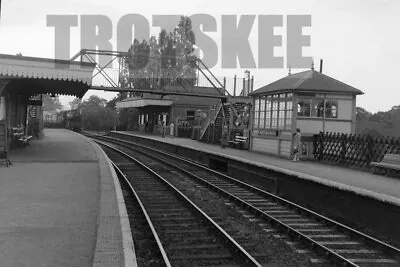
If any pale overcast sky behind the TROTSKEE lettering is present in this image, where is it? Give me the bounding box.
[0,0,400,112]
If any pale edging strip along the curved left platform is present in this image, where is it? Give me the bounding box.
[77,131,137,267]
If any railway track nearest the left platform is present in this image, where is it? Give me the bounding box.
[99,142,262,266]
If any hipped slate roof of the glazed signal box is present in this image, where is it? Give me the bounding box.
[249,69,364,96]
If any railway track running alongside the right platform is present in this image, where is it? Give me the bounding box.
[87,134,400,266]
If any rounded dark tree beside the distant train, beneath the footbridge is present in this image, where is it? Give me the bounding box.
[81,95,118,131]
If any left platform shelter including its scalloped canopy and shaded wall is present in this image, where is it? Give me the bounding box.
[0,54,95,161]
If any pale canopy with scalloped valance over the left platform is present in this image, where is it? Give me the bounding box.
[0,54,95,98]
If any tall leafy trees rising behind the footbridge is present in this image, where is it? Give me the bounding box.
[121,16,196,86]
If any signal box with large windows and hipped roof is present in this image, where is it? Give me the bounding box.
[250,68,363,157]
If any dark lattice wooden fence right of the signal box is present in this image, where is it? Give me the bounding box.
[314,132,400,167]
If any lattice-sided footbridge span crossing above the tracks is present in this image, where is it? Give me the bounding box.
[71,49,254,99]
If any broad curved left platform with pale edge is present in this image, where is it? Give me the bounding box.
[0,129,136,267]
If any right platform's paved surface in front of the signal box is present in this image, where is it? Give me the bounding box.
[117,132,400,205]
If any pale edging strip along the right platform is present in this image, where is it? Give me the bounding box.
[115,131,400,206]
